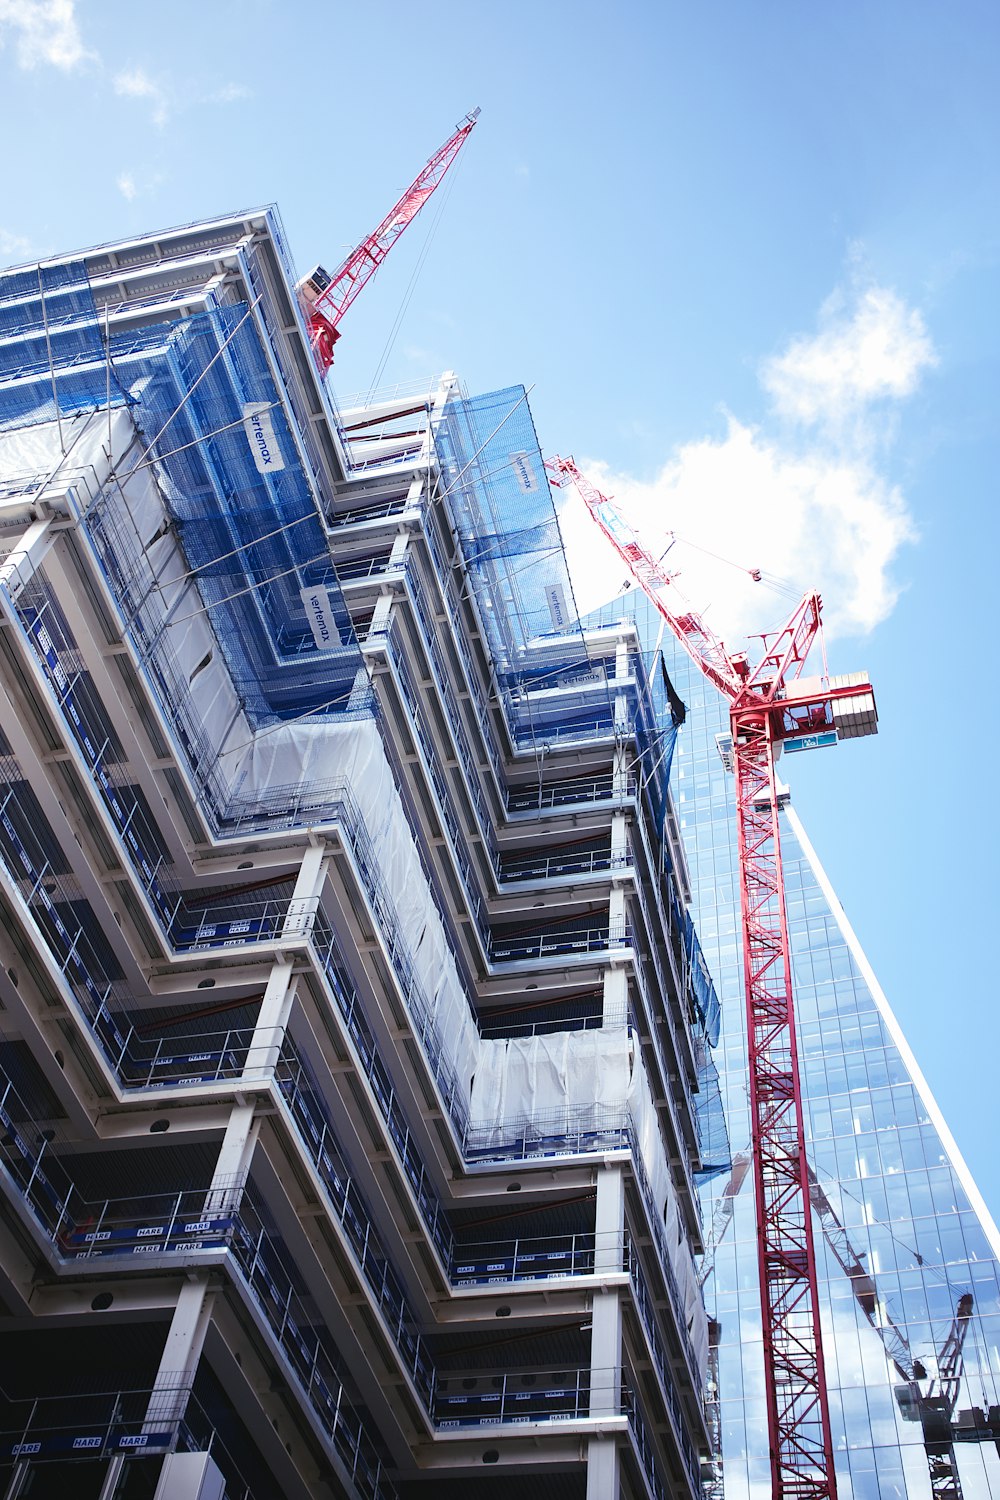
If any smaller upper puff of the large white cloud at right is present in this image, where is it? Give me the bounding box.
[762,287,936,425]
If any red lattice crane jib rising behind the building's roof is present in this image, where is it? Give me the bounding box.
[295,110,480,375]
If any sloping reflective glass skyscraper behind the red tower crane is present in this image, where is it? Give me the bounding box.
[590,596,1000,1500]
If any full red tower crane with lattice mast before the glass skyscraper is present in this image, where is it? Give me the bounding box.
[547,458,877,1500]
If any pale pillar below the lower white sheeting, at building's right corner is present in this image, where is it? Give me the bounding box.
[586,1166,625,1500]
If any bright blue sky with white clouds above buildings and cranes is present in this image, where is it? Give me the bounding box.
[0,0,1000,1212]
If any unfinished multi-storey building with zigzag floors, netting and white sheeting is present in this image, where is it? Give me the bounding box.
[0,199,726,1500]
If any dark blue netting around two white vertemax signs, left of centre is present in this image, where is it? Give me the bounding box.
[112,305,361,726]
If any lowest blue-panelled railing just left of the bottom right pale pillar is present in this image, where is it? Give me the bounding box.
[433,1368,591,1431]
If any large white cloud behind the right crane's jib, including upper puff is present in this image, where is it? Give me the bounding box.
[561,273,934,644]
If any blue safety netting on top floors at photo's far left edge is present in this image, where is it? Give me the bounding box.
[0,261,126,432]
